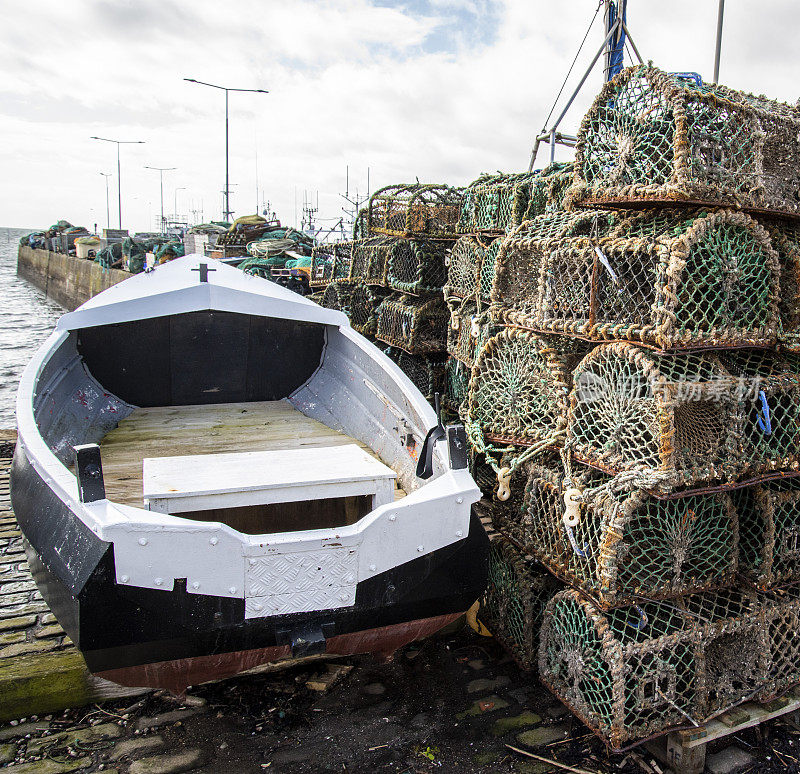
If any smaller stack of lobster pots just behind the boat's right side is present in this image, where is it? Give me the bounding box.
[310,183,463,401]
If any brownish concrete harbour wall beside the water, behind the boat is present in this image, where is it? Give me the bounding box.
[17,246,131,311]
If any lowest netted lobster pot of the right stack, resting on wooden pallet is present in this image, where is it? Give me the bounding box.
[539,590,800,748]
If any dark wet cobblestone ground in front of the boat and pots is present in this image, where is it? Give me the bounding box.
[0,630,800,774]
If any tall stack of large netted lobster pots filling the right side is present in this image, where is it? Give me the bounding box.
[466,66,800,748]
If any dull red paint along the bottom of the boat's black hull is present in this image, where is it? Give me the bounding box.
[96,613,462,694]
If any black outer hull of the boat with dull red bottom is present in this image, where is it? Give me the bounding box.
[11,445,487,692]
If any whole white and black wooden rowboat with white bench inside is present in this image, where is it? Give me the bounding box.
[11,256,487,691]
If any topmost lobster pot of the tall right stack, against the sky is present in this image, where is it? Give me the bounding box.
[568,65,800,215]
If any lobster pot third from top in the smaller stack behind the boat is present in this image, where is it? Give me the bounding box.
[377,293,449,355]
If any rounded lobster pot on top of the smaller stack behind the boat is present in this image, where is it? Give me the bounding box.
[368,183,462,239]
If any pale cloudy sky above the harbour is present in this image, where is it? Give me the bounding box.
[0,0,800,232]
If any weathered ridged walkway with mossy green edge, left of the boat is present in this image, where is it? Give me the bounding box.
[0,457,145,722]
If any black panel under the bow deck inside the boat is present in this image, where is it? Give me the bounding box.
[78,311,325,406]
